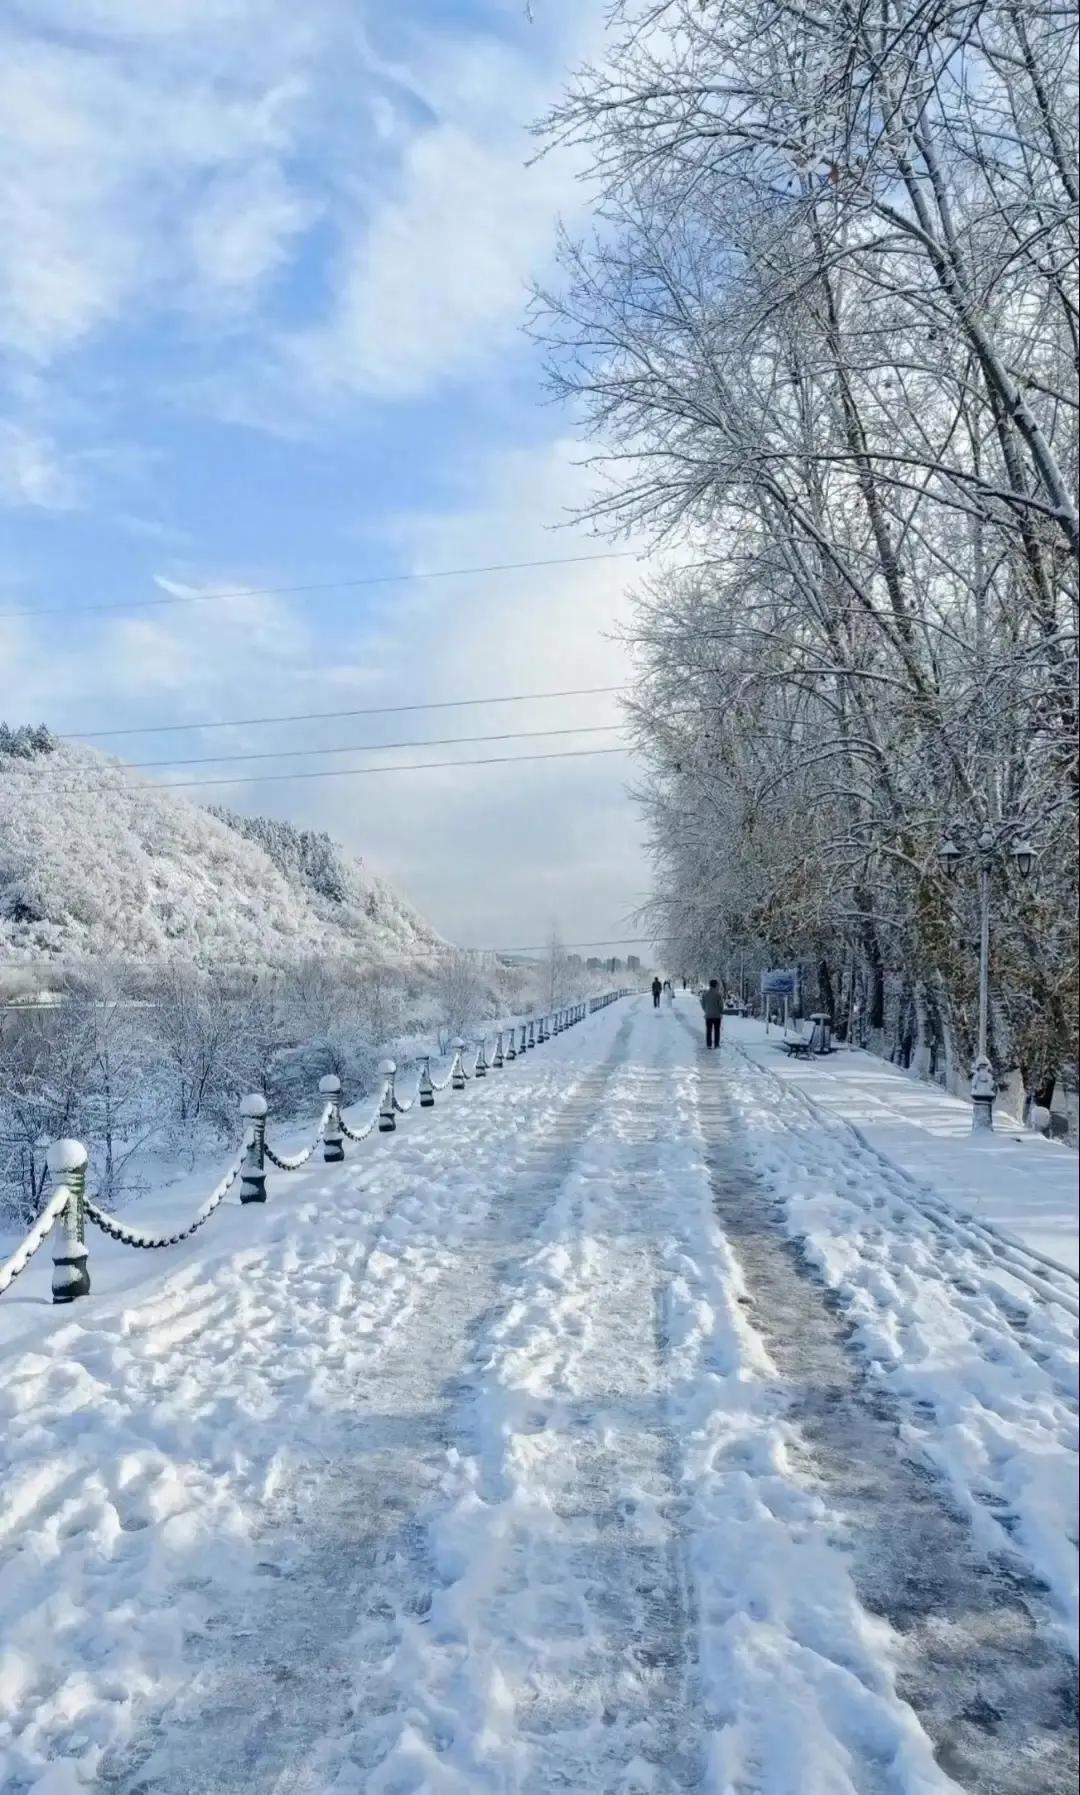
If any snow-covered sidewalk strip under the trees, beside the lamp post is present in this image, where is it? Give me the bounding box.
[725,1018,1080,1271]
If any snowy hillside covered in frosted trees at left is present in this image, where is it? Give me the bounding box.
[0,725,438,966]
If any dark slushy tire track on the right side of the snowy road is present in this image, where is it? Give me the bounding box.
[698,1064,1076,1795]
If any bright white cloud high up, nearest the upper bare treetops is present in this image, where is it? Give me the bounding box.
[281,28,596,397]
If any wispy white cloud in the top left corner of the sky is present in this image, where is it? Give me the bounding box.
[0,5,315,364]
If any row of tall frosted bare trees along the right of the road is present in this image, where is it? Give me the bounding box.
[538,0,1080,1102]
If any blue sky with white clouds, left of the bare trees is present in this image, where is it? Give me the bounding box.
[0,0,648,944]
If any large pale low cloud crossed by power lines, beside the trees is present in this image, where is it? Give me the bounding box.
[290,442,649,946]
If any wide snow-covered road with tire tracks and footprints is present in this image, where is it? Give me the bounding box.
[0,1002,1076,1795]
